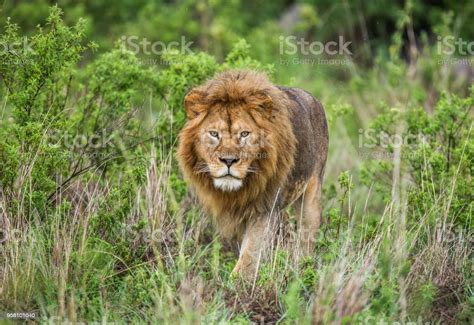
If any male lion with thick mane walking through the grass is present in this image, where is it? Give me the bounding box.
[178,70,328,275]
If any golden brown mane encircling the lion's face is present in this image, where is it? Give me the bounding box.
[178,71,296,238]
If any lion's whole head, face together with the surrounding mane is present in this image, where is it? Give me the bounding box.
[177,71,296,204]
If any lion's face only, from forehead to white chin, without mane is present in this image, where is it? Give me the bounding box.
[195,106,263,191]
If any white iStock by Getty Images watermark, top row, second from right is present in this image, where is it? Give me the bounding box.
[279,35,352,65]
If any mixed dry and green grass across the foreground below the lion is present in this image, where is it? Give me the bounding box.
[0,135,472,324]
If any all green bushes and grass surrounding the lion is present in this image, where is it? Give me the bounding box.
[0,0,474,324]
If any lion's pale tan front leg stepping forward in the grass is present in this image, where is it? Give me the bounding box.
[232,216,277,278]
